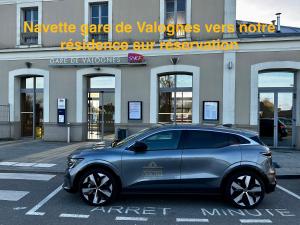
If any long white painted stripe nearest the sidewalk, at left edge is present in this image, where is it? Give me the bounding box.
[0,173,55,181]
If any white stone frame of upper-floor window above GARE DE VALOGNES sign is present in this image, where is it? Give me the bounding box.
[84,0,113,42]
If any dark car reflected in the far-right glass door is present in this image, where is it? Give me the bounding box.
[259,118,288,139]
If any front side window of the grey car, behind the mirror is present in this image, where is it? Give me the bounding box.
[142,130,181,151]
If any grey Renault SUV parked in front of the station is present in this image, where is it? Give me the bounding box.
[64,125,276,208]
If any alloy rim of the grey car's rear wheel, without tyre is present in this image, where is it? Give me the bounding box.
[230,175,263,207]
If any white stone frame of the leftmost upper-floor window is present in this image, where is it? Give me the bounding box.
[16,0,43,48]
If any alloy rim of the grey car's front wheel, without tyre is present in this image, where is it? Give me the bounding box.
[81,173,113,205]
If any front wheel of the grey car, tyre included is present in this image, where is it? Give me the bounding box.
[79,169,118,206]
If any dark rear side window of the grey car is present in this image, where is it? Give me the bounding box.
[181,130,250,149]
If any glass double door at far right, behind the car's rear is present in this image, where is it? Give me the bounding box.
[259,91,295,147]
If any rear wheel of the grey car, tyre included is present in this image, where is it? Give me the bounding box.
[225,172,265,209]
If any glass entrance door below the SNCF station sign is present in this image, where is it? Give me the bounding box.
[88,91,115,140]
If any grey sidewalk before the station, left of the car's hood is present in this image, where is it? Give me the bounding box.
[0,140,95,173]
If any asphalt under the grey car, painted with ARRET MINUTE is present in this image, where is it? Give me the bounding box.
[0,171,300,225]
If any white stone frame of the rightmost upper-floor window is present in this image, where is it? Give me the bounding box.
[160,0,192,41]
